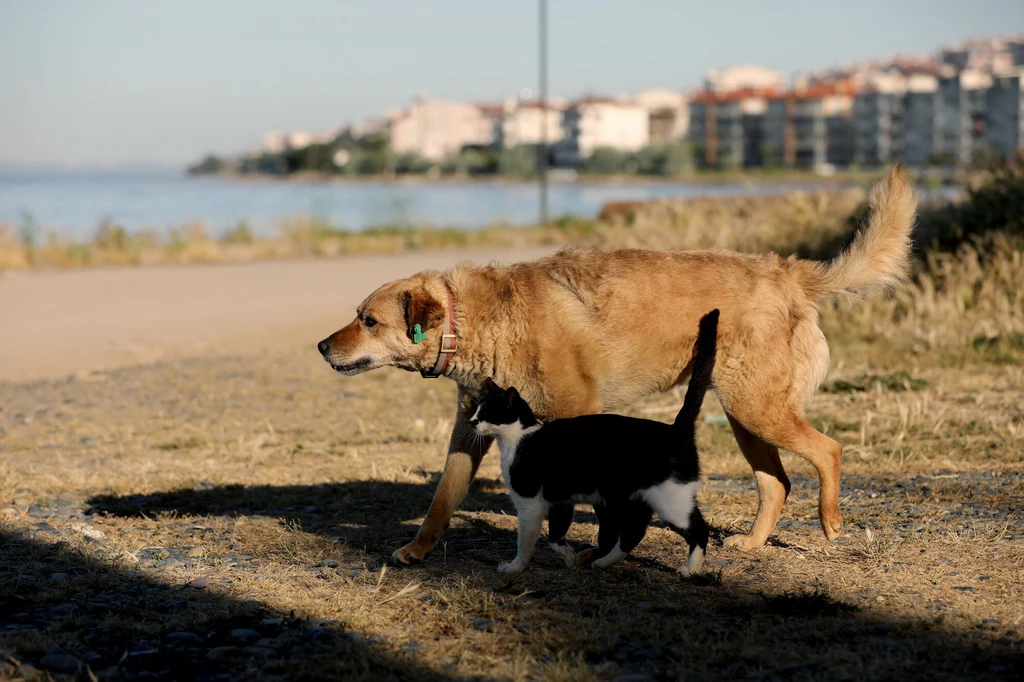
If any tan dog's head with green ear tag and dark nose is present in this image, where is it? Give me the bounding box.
[316,272,446,376]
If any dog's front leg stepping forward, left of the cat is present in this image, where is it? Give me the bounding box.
[391,387,494,565]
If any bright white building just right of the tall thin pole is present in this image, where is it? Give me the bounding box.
[552,97,650,165]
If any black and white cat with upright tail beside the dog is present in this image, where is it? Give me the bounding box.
[472,309,719,574]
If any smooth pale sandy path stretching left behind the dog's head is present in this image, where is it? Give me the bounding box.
[0,248,551,381]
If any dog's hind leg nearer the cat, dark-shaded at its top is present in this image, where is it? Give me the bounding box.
[725,416,791,549]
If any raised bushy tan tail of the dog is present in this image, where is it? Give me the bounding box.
[793,165,918,300]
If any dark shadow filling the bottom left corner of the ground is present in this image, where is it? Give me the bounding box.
[0,532,455,681]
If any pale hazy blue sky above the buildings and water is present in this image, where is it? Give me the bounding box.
[0,0,1024,168]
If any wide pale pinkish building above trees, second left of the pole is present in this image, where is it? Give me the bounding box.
[390,95,495,161]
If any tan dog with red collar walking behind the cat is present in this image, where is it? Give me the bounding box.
[318,167,916,563]
